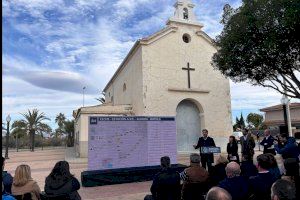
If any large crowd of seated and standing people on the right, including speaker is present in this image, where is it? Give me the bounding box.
[144,129,300,200]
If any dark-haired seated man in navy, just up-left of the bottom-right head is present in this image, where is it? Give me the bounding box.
[249,154,276,200]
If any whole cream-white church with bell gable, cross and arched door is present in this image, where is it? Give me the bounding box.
[73,0,232,157]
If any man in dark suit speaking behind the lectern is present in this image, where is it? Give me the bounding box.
[193,129,216,170]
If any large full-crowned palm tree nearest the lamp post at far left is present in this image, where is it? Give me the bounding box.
[21,109,50,151]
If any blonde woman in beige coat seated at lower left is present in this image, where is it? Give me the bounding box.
[11,165,41,200]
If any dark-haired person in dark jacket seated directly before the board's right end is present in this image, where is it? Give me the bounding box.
[144,156,181,200]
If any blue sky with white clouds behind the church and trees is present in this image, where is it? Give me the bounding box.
[2,0,298,127]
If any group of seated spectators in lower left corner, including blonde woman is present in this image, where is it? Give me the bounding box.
[1,157,81,200]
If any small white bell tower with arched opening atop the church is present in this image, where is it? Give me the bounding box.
[167,0,203,27]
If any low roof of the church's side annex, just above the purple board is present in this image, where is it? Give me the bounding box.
[73,104,133,119]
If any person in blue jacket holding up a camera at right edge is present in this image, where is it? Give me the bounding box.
[274,133,300,161]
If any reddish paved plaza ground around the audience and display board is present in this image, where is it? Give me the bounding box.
[5,148,274,200]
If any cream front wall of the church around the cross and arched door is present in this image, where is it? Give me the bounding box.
[143,23,232,142]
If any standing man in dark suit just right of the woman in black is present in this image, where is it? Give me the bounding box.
[240,129,255,160]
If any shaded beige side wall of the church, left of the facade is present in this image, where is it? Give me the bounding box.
[105,48,144,113]
